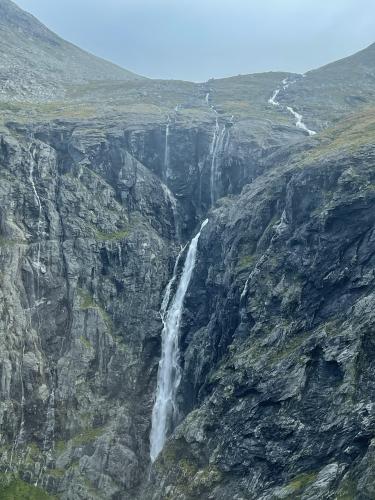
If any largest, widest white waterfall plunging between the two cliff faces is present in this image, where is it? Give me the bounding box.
[150,220,208,462]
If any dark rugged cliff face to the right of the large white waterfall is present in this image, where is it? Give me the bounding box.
[148,111,375,499]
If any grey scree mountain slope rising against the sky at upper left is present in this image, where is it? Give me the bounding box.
[0,0,141,100]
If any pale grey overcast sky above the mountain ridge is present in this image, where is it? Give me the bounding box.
[16,0,375,81]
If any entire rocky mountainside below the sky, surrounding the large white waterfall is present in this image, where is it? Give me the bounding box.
[0,0,375,500]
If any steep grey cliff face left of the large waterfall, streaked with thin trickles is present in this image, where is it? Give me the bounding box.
[0,111,302,498]
